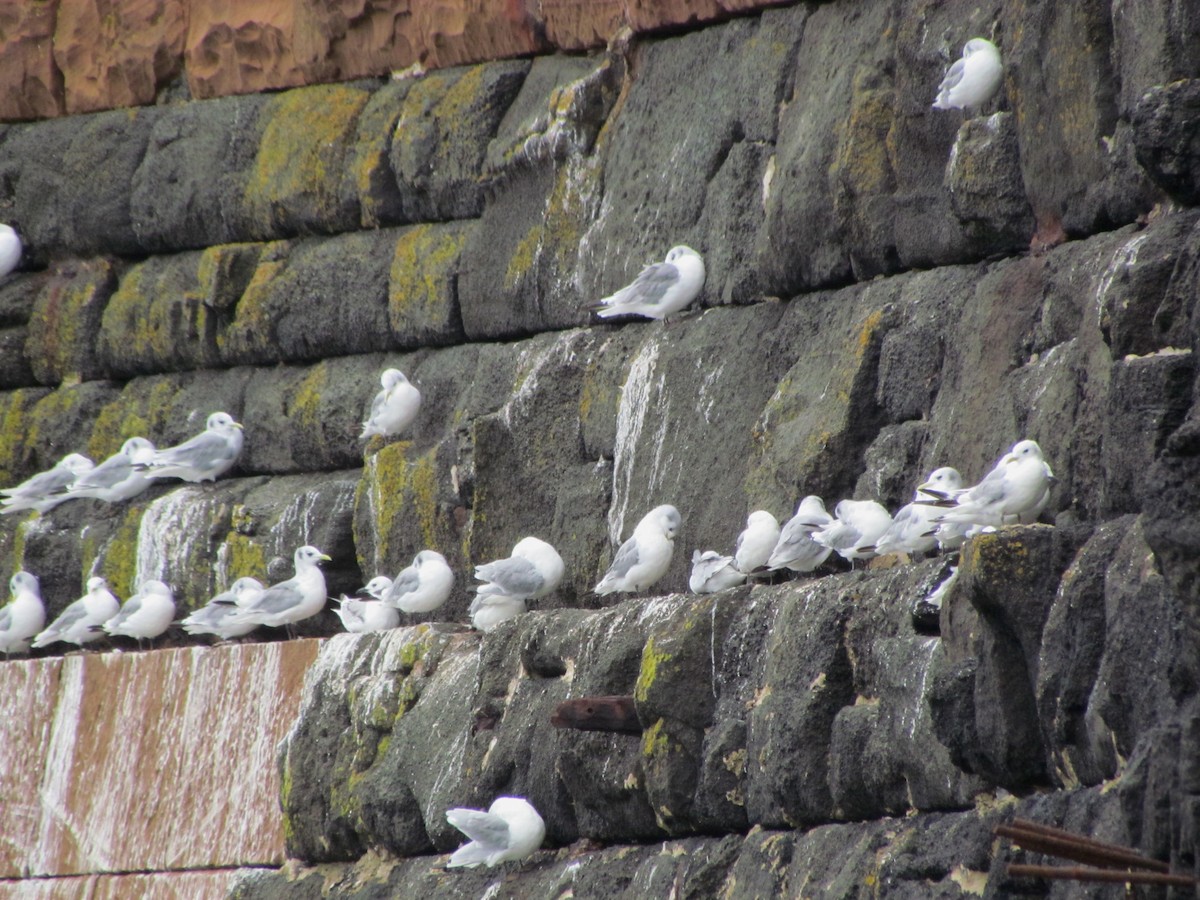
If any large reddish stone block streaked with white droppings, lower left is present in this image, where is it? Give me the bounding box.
[0,640,319,883]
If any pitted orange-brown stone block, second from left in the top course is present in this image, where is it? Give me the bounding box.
[54,0,187,113]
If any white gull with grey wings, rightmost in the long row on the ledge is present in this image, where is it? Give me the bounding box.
[937,440,1055,528]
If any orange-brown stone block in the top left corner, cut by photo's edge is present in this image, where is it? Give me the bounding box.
[0,0,65,119]
